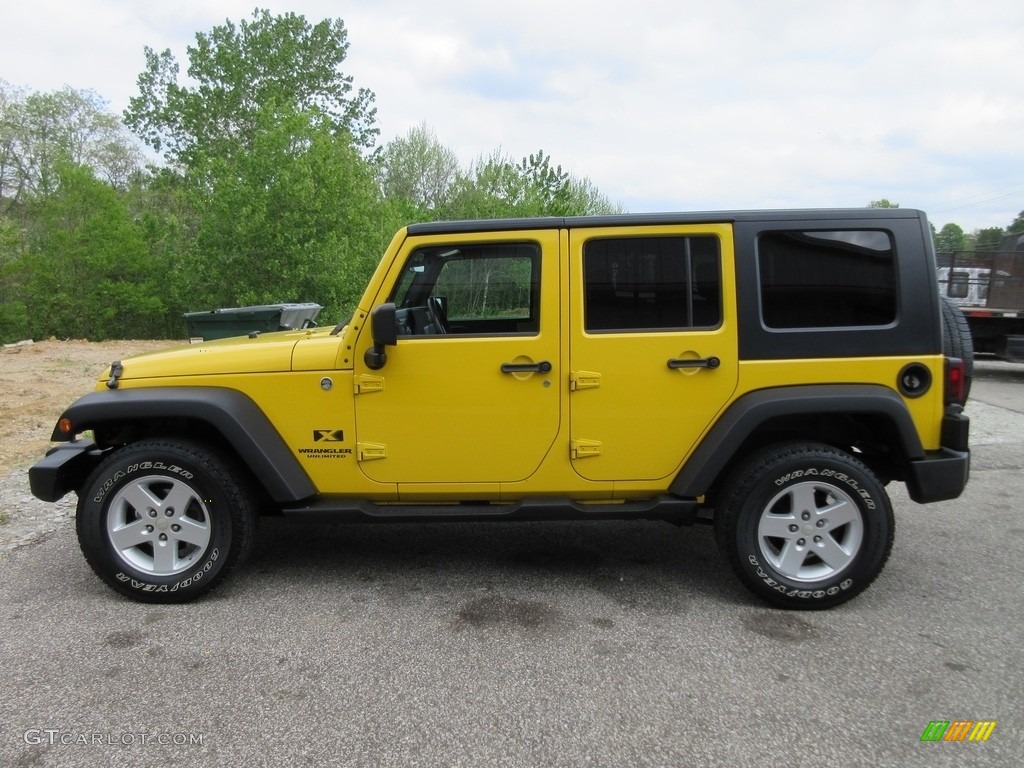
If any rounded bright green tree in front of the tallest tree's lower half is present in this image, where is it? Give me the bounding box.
[187,107,391,316]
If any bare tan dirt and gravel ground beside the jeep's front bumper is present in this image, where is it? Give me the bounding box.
[0,339,183,558]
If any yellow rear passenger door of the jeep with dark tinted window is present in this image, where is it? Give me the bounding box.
[569,224,738,481]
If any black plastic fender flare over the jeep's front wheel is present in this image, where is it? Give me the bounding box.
[50,387,316,502]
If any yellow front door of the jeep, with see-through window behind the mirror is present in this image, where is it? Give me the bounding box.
[355,229,562,489]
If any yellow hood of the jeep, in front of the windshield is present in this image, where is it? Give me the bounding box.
[94,329,340,386]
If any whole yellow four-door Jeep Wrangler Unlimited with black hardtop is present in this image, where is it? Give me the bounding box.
[31,209,970,608]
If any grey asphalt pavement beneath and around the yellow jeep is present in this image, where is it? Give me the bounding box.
[0,361,1024,768]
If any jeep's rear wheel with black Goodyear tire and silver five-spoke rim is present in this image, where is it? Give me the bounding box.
[715,442,895,609]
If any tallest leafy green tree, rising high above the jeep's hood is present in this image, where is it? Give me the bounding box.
[125,9,393,315]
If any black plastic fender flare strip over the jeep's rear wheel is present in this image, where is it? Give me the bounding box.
[669,384,925,498]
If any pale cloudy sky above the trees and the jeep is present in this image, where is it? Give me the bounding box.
[0,0,1024,232]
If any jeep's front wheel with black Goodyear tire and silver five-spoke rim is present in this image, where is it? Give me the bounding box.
[77,439,256,603]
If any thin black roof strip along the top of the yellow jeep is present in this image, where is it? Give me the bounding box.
[409,208,925,234]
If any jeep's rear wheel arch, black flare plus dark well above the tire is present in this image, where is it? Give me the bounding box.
[670,384,925,498]
